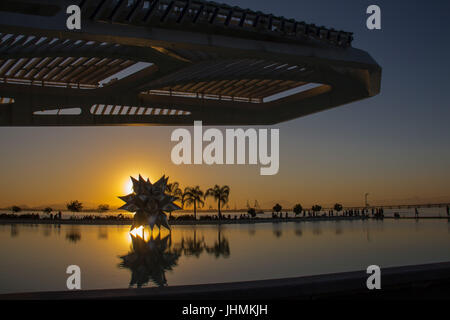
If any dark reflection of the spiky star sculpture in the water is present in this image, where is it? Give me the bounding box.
[119,234,180,288]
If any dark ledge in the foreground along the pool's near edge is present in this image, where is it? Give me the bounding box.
[0,262,450,300]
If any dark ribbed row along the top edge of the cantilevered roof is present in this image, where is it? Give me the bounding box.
[80,0,353,47]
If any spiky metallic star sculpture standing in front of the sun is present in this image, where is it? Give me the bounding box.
[119,175,181,230]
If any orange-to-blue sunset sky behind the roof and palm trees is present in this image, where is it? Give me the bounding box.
[0,0,450,208]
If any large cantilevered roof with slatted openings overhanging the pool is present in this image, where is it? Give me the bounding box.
[0,0,381,126]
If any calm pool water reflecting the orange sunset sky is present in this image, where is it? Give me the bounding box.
[0,220,450,293]
